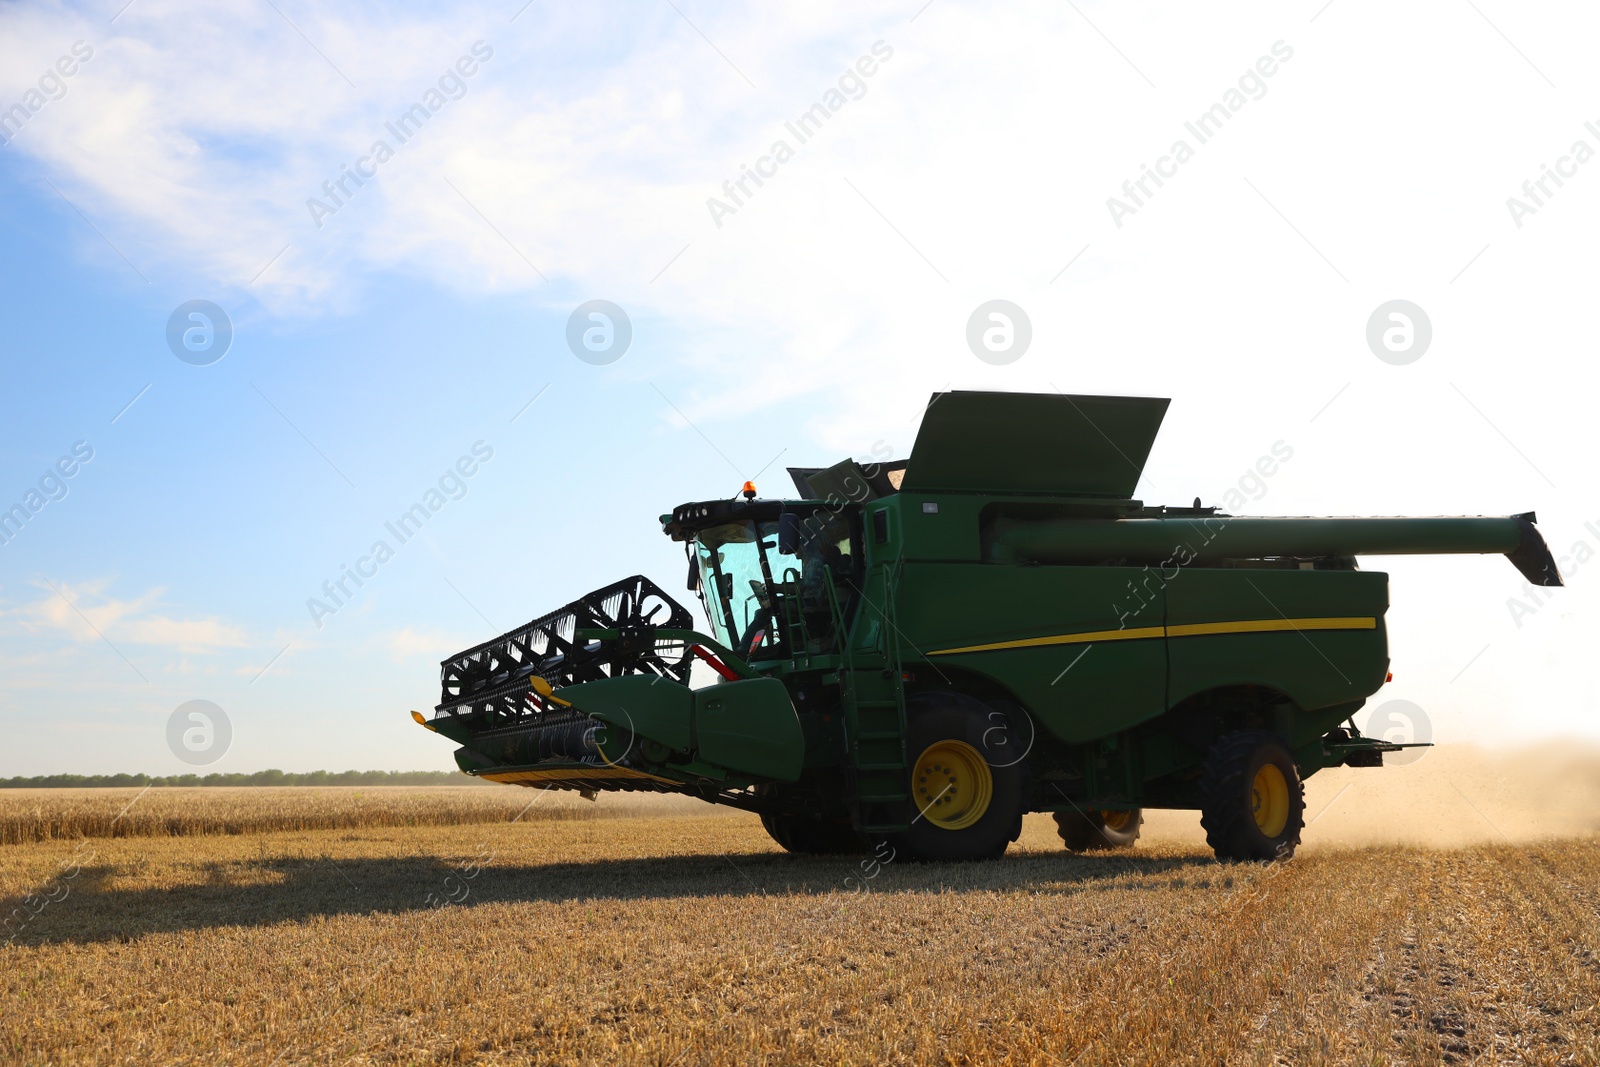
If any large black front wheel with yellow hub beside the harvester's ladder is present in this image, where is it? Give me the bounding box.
[894,693,1027,862]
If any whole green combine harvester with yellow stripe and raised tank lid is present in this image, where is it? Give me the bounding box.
[413,392,1562,861]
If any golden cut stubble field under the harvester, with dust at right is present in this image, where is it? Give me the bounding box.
[0,753,1600,1067]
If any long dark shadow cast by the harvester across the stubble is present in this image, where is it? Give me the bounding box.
[0,853,1230,945]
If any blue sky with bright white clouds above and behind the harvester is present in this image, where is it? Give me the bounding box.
[0,0,1600,776]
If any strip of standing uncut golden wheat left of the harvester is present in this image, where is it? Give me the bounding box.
[0,785,681,845]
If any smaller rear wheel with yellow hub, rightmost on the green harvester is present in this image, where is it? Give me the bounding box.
[1200,729,1306,862]
